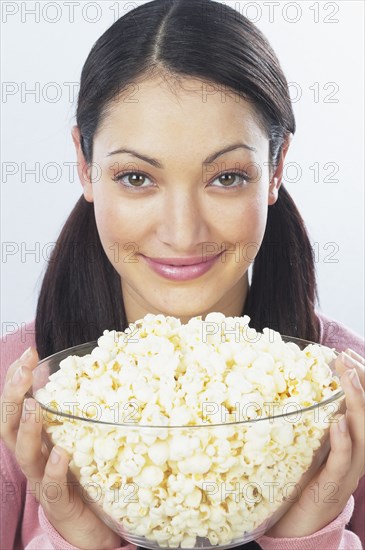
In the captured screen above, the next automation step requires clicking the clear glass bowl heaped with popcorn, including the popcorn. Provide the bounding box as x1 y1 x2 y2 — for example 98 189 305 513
32 312 344 549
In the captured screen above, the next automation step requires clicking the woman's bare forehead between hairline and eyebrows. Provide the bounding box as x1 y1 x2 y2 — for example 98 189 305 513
95 77 264 146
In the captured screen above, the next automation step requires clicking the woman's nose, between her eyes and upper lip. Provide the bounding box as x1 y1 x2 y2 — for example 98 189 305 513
157 189 209 252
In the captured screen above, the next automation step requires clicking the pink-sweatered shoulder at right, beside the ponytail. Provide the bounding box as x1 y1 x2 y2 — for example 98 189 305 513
316 311 365 356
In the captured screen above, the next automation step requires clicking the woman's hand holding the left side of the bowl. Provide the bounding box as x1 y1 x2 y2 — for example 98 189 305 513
1 348 121 550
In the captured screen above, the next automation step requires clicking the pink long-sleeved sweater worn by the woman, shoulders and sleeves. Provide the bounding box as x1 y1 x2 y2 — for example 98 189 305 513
0 314 365 550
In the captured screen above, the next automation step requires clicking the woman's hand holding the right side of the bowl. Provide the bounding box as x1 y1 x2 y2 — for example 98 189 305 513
266 349 365 538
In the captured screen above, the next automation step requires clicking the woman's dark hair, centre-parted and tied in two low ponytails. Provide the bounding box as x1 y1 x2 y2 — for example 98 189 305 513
36 0 318 357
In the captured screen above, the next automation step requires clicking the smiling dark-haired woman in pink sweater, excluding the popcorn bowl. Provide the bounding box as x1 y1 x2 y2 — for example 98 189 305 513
2 0 364 550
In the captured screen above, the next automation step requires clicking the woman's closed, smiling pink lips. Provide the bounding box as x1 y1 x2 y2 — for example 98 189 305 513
142 252 222 281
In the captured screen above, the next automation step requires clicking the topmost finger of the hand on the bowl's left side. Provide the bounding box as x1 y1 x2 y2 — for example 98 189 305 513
1 348 38 451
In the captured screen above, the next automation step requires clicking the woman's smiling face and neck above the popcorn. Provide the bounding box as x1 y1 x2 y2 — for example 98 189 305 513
74 73 280 322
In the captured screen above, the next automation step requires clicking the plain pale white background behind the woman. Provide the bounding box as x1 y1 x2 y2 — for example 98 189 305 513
1 0 364 334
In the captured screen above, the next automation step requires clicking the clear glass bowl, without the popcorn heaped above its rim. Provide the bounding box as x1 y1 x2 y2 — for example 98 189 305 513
29 336 344 549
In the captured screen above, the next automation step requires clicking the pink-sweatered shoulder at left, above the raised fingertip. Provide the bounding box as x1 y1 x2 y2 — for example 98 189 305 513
0 320 35 394
